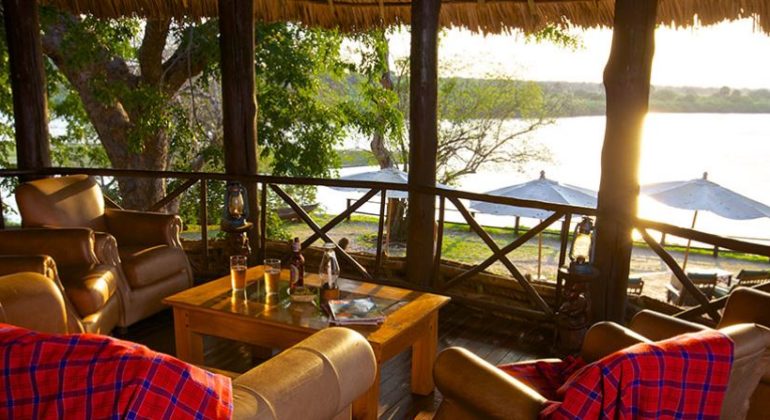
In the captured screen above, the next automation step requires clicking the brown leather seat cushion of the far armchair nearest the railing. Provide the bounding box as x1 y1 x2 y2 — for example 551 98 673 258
118 245 187 289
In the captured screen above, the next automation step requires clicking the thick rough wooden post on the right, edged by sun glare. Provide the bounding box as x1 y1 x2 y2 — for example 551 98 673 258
591 0 658 322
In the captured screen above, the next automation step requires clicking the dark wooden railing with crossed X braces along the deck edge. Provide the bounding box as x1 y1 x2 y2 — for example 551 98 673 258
0 168 770 320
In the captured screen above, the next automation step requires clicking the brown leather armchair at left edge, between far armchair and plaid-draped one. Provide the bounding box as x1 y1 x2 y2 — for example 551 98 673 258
0 240 120 334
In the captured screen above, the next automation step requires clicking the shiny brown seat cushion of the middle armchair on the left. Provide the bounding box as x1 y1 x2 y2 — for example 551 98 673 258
59 264 118 316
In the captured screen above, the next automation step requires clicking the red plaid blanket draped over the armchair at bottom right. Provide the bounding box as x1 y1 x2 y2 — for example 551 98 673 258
505 331 733 419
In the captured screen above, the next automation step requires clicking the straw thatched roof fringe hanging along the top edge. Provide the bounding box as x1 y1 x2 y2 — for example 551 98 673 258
42 0 770 33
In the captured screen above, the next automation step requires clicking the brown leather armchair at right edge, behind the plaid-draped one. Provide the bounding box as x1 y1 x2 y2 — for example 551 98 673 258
629 287 770 419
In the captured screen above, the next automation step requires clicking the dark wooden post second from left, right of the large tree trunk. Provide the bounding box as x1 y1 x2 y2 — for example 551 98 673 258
218 0 264 256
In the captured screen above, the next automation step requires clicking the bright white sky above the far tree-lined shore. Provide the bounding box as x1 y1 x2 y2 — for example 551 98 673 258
390 19 770 89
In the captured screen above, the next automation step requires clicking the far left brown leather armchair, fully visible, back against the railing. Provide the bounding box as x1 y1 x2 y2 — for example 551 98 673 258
16 175 193 327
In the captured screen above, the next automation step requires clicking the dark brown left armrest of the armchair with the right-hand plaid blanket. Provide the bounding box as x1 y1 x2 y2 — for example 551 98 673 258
433 347 546 419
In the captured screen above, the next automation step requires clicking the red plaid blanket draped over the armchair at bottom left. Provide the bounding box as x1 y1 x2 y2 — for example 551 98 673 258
0 324 232 419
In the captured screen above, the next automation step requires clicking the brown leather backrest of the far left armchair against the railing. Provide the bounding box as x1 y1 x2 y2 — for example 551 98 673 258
16 175 106 231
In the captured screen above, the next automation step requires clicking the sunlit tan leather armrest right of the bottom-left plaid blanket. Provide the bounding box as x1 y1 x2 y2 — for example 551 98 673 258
233 328 377 419
